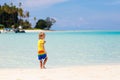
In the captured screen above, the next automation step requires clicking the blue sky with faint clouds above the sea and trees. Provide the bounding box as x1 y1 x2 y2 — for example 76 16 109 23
0 0 120 30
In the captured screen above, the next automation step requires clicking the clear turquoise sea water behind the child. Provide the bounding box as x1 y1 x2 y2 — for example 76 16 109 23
0 31 120 68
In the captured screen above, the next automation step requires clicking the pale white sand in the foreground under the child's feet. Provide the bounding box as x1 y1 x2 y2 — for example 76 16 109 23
0 65 120 80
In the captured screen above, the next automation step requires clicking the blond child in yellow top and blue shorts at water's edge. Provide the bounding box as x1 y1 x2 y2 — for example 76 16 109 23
38 32 48 69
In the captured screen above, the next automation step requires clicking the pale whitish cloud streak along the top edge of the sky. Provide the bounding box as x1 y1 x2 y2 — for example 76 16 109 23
23 0 68 8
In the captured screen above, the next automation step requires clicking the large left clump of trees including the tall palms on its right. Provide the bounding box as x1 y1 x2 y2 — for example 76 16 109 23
0 3 31 28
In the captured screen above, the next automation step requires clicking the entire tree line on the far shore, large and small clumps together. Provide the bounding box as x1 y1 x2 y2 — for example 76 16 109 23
0 2 56 30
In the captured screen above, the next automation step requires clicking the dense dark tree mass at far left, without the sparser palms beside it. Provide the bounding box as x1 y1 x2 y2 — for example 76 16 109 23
0 4 18 27
